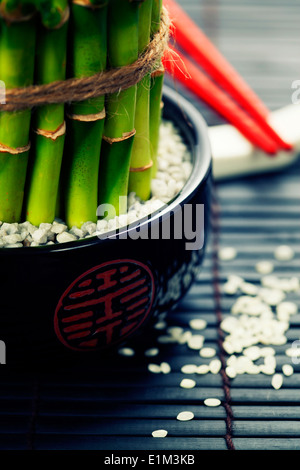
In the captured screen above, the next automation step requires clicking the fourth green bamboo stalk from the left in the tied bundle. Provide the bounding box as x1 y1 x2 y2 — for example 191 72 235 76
99 0 139 218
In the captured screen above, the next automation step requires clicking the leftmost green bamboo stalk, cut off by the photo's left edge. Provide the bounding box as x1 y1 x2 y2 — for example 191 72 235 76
0 0 36 223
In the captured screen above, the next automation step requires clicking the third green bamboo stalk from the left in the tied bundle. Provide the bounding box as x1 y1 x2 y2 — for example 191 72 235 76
62 0 107 227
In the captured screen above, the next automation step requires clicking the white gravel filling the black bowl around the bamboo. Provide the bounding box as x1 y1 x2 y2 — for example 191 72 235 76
0 121 192 248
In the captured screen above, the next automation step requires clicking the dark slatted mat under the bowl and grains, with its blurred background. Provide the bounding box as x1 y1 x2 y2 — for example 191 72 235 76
0 0 300 451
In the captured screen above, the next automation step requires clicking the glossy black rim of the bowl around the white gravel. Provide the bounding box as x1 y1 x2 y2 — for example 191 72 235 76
0 85 212 257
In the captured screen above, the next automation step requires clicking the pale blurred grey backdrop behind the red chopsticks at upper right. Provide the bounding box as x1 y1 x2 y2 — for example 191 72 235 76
166 0 300 125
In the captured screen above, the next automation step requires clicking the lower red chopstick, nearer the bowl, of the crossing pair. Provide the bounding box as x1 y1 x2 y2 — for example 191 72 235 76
163 47 278 154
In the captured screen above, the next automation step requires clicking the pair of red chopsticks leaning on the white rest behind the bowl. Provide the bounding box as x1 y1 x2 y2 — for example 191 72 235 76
163 0 292 155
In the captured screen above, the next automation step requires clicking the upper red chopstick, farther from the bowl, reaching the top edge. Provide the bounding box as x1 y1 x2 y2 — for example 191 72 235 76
164 0 292 150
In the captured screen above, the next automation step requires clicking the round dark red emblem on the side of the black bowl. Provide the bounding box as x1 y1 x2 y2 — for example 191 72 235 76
54 259 155 351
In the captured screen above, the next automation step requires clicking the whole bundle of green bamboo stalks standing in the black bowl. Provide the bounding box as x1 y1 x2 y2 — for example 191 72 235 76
0 0 164 227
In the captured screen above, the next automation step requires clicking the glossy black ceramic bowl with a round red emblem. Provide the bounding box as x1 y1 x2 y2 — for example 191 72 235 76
0 88 211 365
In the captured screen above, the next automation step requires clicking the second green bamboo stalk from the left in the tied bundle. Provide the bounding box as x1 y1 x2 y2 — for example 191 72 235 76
25 0 69 225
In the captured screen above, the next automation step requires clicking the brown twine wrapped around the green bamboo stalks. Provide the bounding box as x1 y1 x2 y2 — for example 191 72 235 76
1 8 170 112
